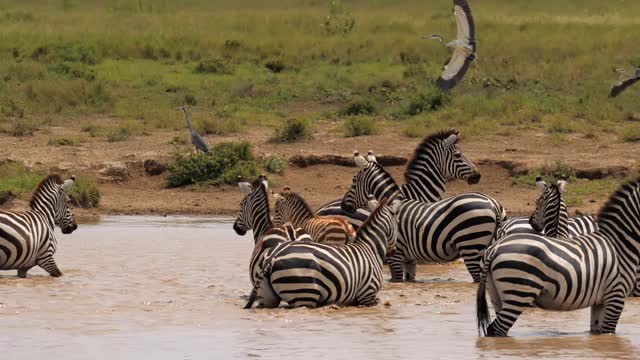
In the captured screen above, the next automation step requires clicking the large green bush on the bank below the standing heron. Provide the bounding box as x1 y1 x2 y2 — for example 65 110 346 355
166 142 259 188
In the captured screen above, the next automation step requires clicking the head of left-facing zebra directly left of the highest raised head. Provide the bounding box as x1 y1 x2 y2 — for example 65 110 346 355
340 162 400 214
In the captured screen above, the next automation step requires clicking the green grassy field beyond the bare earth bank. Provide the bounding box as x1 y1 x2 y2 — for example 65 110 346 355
0 0 640 142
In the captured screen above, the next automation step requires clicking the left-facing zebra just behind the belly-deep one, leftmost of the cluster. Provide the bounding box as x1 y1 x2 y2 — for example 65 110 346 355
233 179 311 306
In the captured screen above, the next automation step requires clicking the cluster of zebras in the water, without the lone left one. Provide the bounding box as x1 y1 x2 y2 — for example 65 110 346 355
233 130 640 336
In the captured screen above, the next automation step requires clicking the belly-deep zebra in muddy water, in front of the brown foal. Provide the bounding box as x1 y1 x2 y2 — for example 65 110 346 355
245 199 398 308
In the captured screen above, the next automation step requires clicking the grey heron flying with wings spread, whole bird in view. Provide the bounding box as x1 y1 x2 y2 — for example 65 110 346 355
425 0 476 91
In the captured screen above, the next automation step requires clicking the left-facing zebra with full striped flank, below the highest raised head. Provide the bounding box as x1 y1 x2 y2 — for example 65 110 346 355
342 163 507 282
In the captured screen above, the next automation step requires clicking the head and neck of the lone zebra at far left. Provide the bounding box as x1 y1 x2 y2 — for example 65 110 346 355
30 175 78 234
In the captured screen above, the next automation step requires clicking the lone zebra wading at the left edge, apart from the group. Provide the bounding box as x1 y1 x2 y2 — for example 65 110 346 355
0 174 78 278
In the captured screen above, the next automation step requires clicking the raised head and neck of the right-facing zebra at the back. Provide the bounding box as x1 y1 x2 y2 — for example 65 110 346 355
405 129 480 192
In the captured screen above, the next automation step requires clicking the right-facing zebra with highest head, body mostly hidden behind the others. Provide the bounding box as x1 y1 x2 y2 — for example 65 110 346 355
316 129 480 229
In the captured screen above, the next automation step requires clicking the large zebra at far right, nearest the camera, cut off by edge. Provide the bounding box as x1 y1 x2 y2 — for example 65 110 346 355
476 178 640 336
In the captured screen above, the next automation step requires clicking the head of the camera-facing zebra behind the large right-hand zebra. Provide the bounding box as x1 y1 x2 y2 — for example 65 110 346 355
529 176 567 236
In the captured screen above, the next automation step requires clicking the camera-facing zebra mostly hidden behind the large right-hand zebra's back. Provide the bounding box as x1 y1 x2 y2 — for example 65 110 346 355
496 176 598 239
